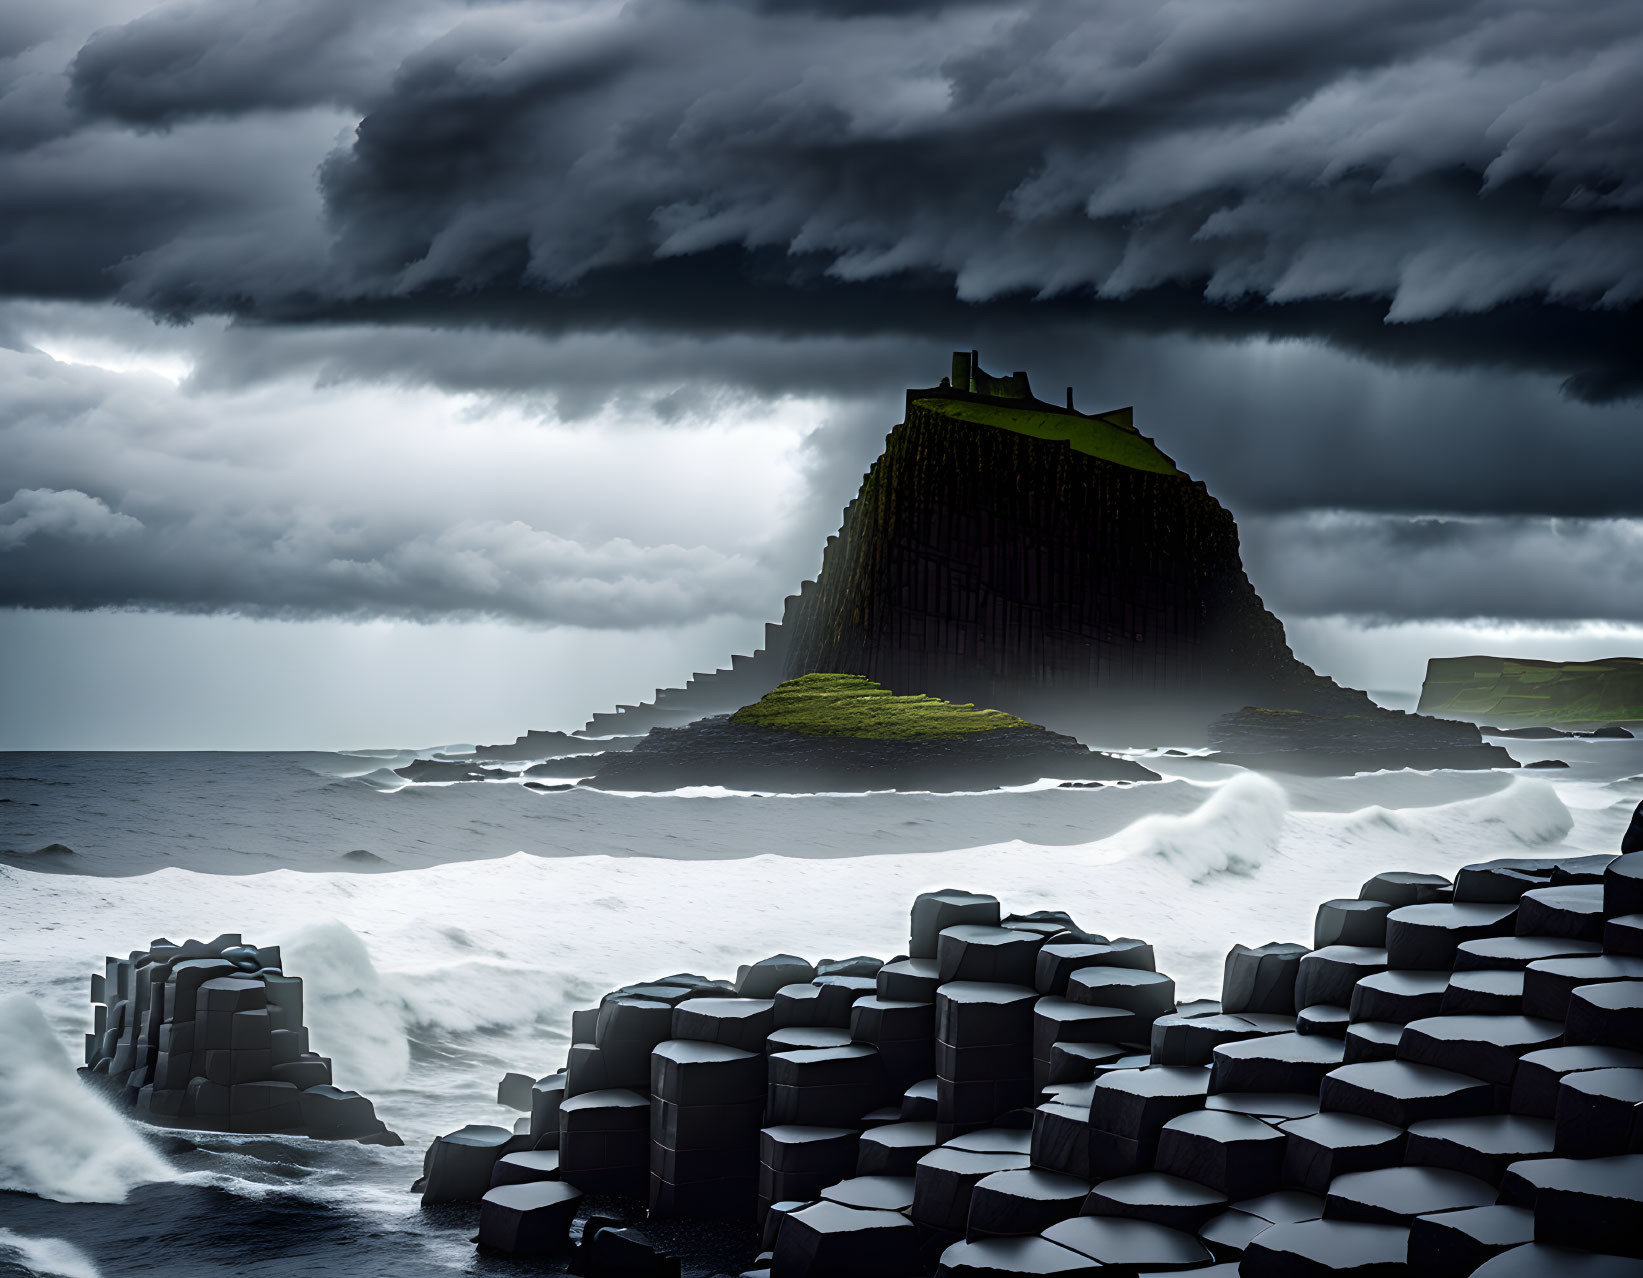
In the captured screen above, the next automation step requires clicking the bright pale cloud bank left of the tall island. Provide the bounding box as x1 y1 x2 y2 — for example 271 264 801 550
0 343 785 629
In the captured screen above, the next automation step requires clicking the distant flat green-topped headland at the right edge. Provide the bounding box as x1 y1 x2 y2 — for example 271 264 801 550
1418 657 1643 728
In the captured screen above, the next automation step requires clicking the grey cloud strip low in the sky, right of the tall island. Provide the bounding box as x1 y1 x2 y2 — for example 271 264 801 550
1242 511 1643 623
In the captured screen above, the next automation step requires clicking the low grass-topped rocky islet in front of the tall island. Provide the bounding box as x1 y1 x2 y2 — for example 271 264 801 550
585 672 1157 793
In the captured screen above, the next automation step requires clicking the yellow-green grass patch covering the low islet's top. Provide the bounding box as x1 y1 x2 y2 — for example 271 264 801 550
731 675 1033 741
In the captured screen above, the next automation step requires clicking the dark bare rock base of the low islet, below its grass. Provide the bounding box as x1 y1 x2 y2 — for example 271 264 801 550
583 716 1158 792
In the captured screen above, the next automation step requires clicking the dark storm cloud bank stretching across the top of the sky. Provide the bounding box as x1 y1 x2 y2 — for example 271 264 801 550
0 0 1643 401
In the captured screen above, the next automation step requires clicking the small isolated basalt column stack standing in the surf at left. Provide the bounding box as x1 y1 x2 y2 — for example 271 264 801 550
85 933 401 1145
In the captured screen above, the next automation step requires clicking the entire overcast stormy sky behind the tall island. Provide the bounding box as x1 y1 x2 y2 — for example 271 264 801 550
0 0 1643 749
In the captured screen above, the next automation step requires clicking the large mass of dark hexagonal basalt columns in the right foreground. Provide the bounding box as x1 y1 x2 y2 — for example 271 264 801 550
419 801 1643 1278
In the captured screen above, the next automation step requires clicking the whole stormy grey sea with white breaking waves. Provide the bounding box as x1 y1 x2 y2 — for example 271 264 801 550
0 739 1643 1278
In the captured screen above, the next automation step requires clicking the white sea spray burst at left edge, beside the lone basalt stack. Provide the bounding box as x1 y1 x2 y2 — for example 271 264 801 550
0 994 171 1195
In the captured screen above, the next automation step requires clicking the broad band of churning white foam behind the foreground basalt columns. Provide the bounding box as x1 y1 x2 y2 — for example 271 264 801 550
0 774 1623 1152
